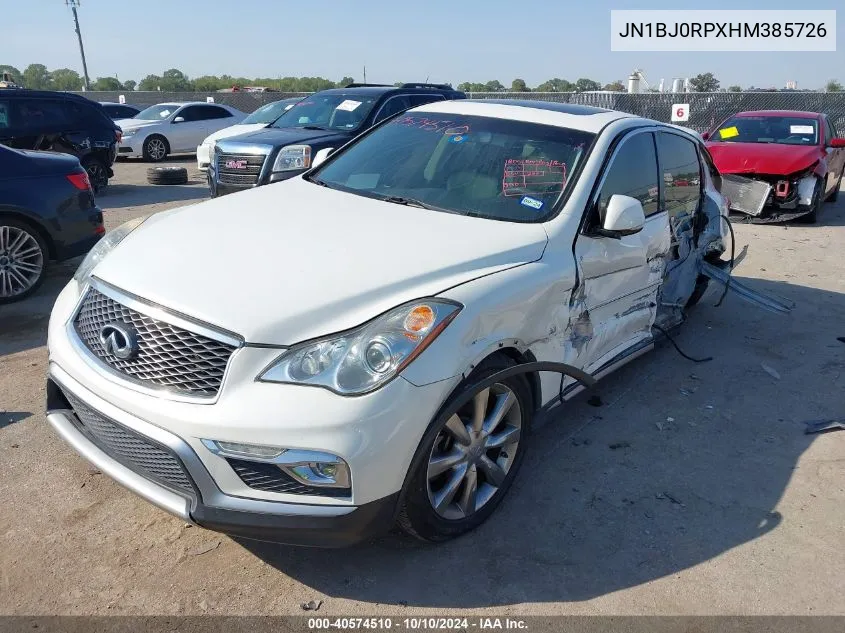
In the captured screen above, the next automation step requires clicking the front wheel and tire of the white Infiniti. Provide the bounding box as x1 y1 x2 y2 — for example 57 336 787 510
397 356 534 542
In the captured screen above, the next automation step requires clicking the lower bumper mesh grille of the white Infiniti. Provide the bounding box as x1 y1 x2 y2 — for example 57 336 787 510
63 391 195 495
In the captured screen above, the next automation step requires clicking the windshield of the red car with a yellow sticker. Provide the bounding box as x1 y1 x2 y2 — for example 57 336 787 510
708 116 819 145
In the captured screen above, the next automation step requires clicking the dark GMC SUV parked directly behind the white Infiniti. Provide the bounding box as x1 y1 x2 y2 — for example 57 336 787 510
208 83 466 197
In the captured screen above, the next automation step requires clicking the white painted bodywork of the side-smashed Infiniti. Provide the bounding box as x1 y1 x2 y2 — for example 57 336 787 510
48 101 726 544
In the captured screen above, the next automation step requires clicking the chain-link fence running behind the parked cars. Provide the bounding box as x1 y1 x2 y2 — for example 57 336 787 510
78 92 845 135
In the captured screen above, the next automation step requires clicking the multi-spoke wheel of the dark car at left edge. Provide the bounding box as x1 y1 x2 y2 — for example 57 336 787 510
0 217 48 304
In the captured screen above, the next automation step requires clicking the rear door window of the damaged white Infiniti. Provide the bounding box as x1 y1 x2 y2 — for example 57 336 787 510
657 132 701 218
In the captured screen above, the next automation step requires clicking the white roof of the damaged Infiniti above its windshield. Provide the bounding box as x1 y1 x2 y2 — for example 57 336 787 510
409 99 638 133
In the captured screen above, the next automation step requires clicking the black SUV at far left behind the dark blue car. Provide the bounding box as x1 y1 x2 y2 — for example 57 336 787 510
0 89 120 191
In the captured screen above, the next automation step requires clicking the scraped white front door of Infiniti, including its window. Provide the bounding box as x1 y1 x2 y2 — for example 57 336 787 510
565 130 671 373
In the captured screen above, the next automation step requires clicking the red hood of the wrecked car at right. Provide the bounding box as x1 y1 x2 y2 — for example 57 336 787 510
707 143 819 176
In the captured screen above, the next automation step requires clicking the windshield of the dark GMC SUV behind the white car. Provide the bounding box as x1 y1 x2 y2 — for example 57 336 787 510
273 93 376 130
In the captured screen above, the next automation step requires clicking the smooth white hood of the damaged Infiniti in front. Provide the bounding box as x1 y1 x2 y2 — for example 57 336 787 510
94 178 547 345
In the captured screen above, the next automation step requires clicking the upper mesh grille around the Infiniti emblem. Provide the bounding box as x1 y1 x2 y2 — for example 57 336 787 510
73 288 236 397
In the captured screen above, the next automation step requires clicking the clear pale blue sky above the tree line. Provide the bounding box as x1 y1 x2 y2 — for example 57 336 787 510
0 0 845 88
